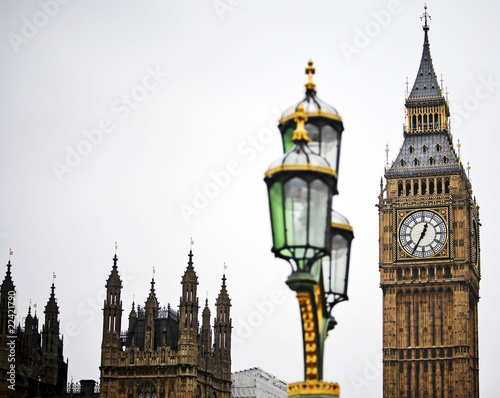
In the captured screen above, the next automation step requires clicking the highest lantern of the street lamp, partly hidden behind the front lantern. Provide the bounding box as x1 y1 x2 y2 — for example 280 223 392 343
278 61 344 180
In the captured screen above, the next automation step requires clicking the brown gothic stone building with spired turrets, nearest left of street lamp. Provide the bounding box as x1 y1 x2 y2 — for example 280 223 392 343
100 251 231 398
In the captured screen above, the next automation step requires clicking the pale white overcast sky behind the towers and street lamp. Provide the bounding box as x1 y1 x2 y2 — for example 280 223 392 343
0 0 500 397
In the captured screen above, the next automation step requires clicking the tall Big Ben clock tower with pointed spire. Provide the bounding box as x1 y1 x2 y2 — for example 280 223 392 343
378 7 481 398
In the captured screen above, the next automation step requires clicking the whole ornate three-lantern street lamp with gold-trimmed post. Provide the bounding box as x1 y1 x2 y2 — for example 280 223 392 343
264 61 354 398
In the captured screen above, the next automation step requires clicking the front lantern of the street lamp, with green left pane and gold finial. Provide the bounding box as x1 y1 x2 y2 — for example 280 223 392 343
264 105 336 282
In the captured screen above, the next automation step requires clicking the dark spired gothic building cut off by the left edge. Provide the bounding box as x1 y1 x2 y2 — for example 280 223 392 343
0 260 68 398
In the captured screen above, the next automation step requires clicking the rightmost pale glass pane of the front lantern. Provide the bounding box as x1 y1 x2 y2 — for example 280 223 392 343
309 180 331 249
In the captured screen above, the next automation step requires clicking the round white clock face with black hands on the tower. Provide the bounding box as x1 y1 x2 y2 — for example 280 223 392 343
399 210 447 257
